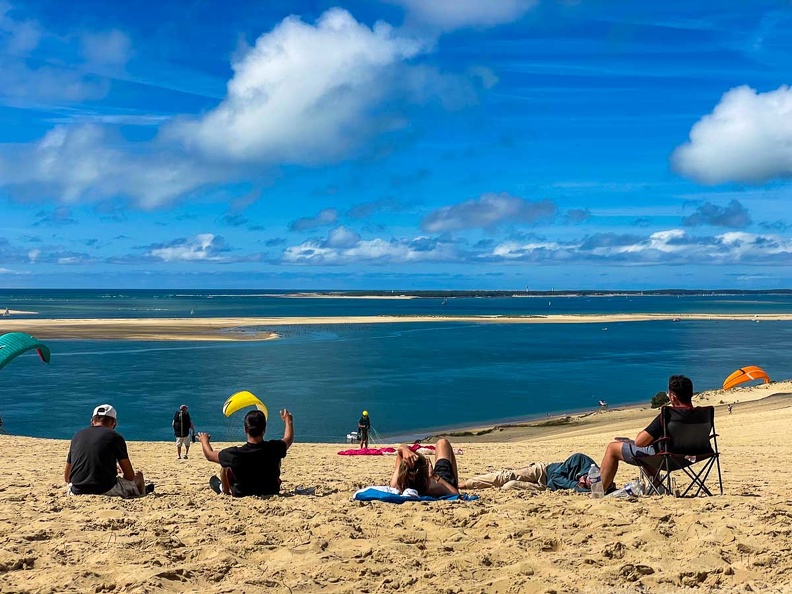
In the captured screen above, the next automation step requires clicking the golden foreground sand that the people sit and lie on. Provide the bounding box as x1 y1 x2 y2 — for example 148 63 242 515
0 383 792 594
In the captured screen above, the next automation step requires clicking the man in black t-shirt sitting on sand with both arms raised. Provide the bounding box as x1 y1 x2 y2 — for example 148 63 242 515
198 409 294 497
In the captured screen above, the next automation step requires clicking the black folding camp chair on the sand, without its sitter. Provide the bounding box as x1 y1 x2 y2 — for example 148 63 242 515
635 406 723 497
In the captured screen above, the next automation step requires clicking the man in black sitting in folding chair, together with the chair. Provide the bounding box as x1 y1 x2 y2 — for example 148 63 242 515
601 375 723 497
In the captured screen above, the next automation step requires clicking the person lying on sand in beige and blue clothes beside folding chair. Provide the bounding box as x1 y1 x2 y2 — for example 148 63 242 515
459 454 595 492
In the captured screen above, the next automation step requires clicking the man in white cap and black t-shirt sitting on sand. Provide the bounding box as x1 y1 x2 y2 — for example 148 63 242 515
63 404 148 498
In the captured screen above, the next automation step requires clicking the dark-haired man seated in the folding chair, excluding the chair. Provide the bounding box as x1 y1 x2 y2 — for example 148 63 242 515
600 375 694 493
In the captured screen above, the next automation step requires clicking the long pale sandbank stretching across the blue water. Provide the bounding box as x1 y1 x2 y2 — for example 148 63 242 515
0 313 792 340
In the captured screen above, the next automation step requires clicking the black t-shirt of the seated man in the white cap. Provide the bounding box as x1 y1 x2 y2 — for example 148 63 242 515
66 426 129 495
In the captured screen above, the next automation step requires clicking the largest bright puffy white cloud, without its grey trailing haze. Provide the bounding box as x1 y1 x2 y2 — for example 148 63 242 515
166 8 425 164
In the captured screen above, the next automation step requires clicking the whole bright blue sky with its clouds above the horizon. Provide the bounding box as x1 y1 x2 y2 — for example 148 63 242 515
0 0 792 290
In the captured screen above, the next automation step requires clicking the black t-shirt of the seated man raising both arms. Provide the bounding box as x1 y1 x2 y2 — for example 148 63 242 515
219 439 287 497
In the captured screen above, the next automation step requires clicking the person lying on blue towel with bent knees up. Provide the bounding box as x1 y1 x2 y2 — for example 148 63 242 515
390 438 459 497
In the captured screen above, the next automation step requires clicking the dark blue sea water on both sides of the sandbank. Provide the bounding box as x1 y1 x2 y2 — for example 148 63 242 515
0 290 792 443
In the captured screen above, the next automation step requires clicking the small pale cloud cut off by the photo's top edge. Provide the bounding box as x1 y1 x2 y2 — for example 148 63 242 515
389 0 538 31
